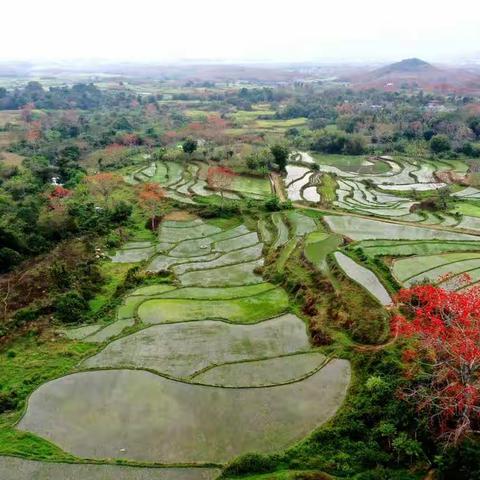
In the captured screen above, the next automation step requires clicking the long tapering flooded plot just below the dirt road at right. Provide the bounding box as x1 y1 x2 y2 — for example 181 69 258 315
324 215 480 241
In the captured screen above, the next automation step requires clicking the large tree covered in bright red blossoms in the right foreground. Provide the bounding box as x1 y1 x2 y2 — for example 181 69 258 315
392 285 480 443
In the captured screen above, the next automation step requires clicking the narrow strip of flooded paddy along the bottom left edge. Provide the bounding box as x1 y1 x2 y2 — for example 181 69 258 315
0 457 220 480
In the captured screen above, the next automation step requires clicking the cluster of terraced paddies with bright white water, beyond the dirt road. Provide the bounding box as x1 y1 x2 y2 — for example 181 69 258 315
285 152 480 231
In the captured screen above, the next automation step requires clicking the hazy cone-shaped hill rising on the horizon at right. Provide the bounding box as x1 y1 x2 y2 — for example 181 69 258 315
348 58 480 93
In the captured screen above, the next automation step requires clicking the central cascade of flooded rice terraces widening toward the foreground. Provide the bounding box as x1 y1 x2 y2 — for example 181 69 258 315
20 216 350 466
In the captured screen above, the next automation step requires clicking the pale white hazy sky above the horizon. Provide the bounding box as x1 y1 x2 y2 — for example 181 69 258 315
0 0 480 61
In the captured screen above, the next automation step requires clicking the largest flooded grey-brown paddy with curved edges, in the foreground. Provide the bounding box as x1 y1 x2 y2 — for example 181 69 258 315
18 366 350 463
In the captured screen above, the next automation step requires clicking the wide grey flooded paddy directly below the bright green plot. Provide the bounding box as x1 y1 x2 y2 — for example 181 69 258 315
82 314 308 378
